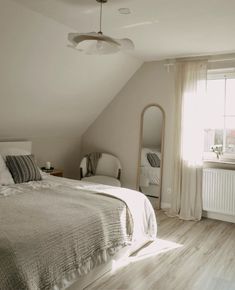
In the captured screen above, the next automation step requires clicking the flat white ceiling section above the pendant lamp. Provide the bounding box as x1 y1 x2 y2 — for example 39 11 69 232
15 0 235 61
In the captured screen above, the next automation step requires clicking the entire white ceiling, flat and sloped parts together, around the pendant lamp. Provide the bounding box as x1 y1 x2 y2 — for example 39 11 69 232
0 0 235 138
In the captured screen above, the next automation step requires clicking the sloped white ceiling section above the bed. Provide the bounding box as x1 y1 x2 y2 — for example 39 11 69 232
0 0 142 139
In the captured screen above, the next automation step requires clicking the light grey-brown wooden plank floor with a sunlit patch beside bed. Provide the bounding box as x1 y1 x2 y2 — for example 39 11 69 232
86 211 235 290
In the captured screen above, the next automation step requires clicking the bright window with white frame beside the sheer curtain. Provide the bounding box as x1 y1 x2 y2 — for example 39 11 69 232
204 69 235 161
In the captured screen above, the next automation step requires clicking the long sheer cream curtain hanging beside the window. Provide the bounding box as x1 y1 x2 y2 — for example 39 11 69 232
170 61 207 220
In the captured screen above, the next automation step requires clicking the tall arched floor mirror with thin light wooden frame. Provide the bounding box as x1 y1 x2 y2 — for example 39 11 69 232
137 104 165 209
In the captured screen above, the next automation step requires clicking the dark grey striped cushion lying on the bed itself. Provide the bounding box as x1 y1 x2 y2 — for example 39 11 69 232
6 155 42 183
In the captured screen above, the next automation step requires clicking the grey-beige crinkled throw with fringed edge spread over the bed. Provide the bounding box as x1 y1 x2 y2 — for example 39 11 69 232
0 180 132 290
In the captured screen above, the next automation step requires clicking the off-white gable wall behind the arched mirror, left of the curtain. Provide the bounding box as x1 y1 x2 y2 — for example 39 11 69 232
82 62 174 203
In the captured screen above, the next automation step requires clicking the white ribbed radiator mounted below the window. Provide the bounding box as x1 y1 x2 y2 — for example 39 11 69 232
202 168 235 215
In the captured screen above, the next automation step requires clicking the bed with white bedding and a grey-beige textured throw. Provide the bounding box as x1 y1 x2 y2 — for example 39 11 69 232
0 142 157 290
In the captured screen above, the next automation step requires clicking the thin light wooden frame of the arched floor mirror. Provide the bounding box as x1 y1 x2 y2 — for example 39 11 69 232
136 103 166 209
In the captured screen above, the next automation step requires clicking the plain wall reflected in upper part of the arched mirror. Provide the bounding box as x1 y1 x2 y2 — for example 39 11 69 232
143 106 163 148
